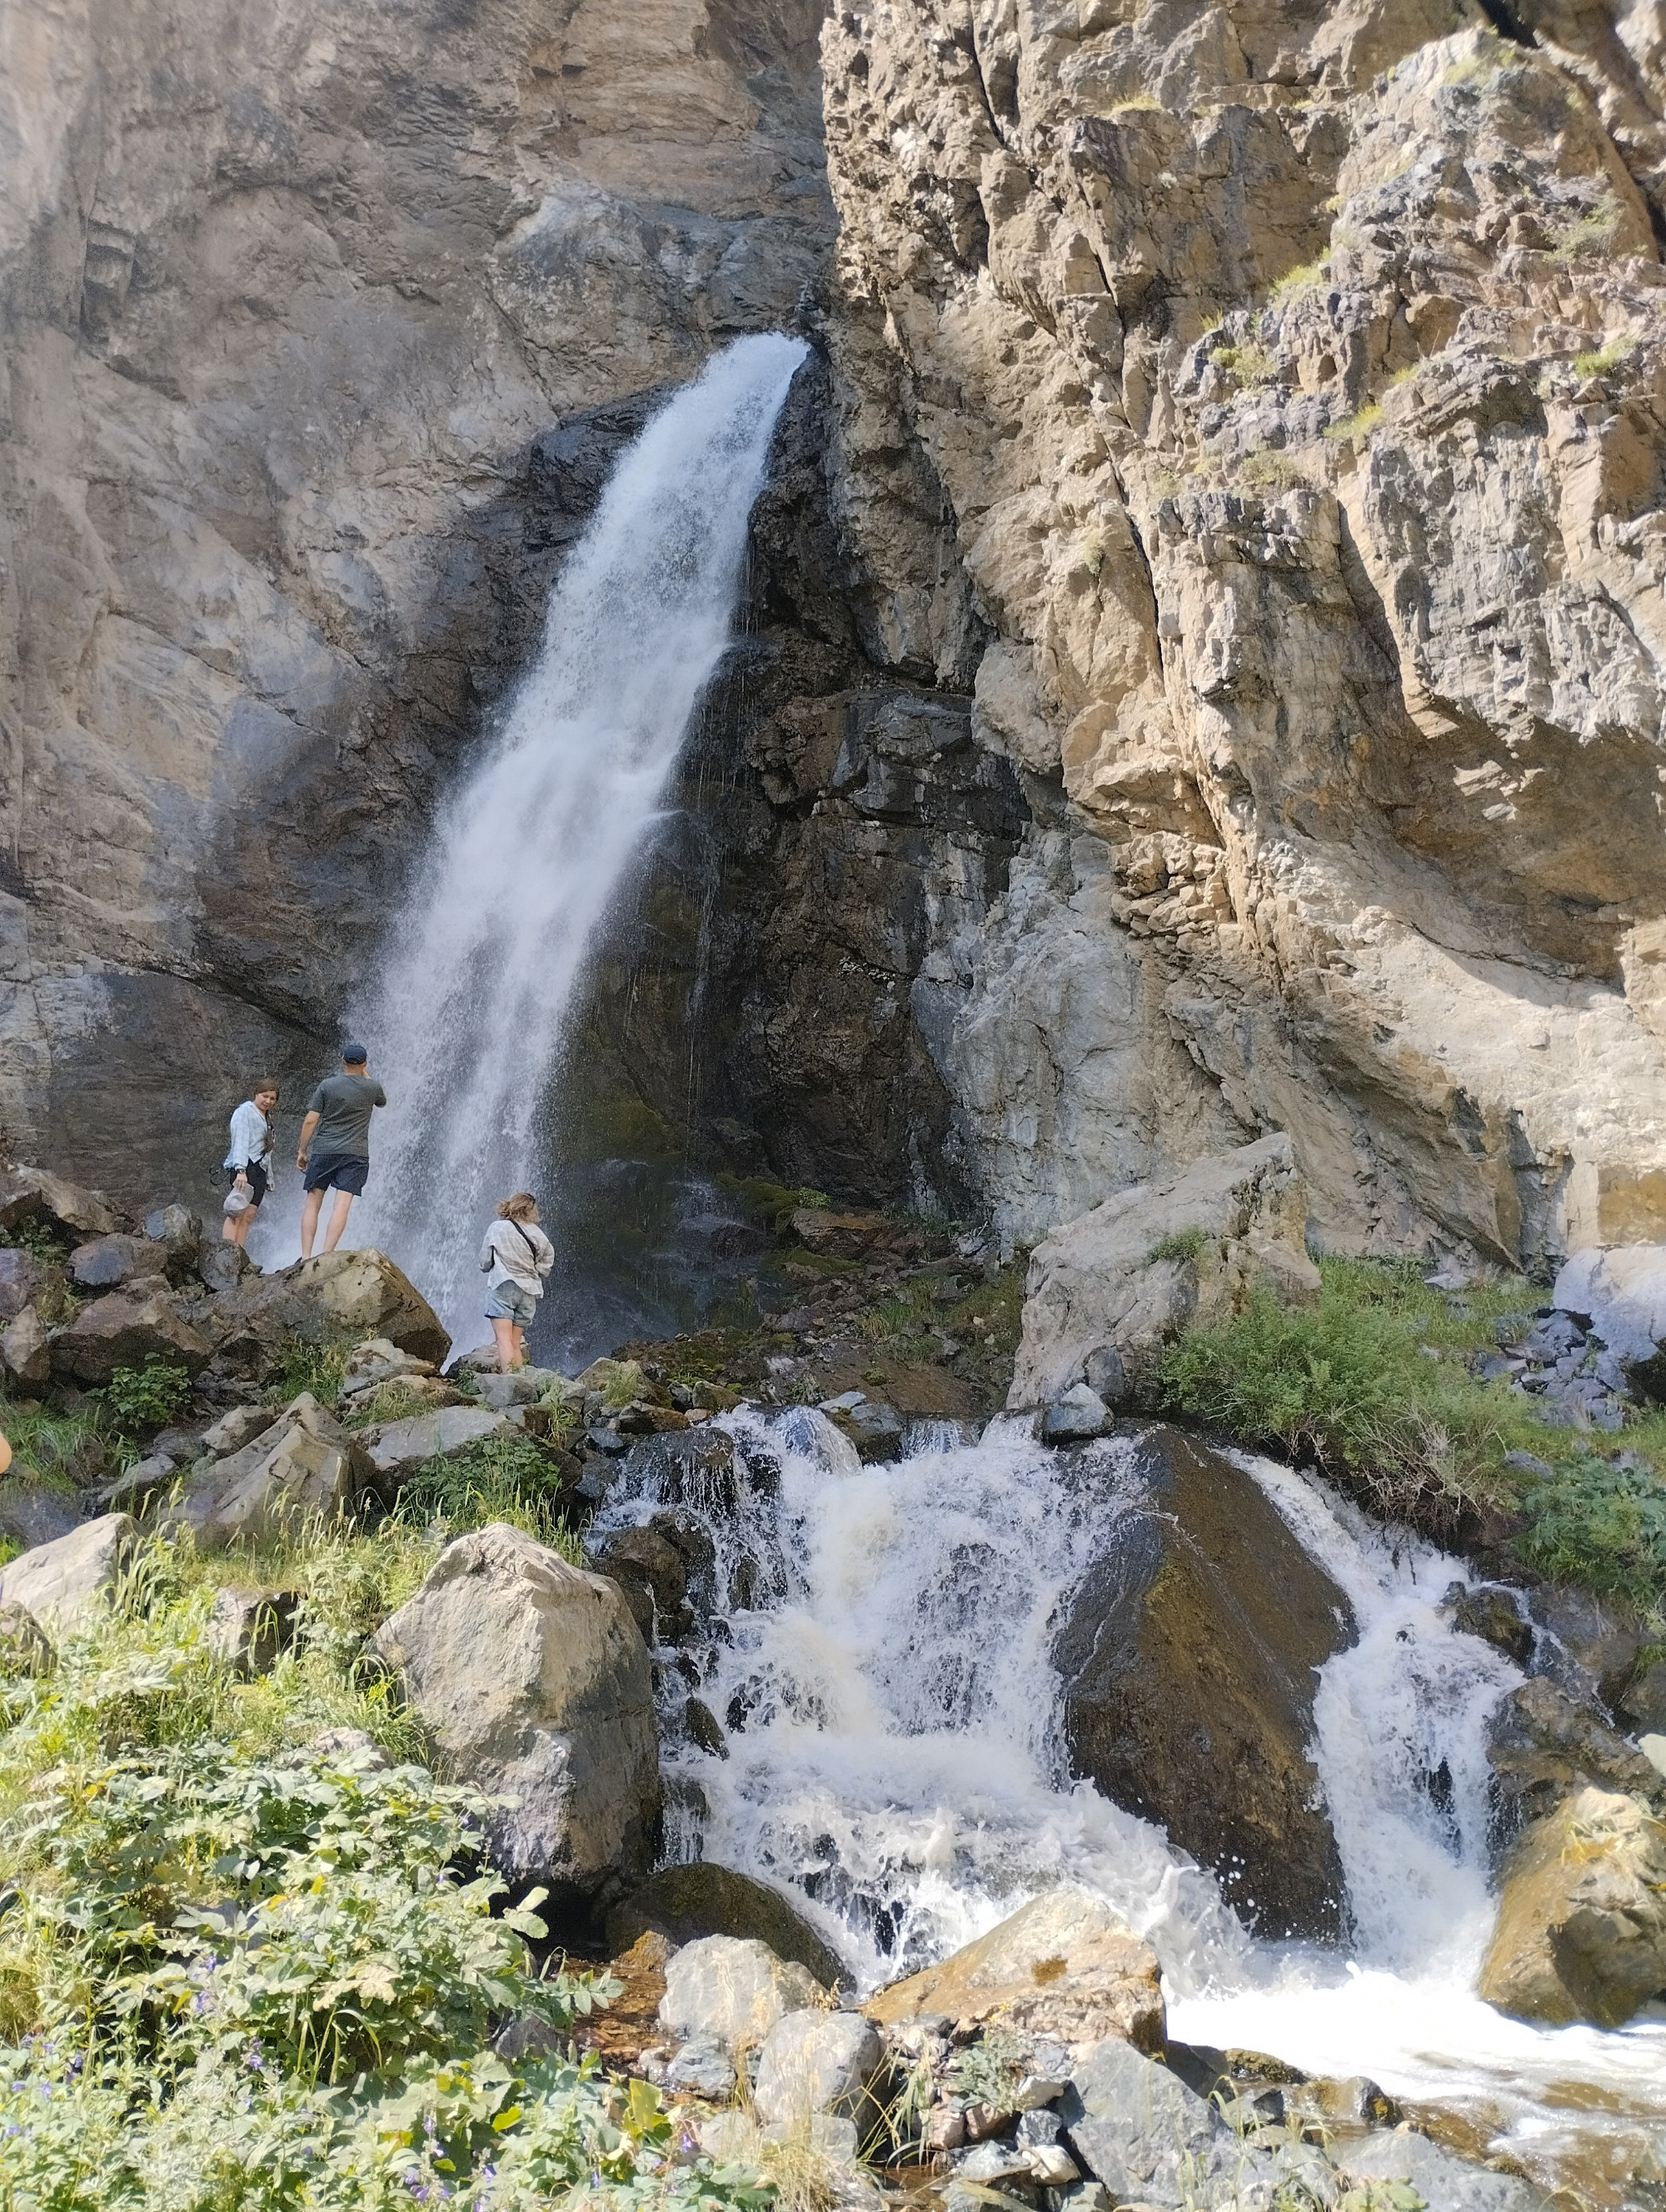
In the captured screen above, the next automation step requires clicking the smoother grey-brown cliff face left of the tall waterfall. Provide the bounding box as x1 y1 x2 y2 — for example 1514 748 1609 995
0 0 832 1197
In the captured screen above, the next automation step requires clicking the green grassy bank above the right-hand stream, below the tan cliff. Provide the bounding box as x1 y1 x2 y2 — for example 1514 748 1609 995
1160 1258 1666 1617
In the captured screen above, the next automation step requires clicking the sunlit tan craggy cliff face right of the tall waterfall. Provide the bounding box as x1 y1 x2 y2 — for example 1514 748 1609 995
823 0 1666 1261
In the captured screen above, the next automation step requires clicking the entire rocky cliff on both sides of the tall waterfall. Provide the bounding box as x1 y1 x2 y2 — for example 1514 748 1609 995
0 0 1666 1265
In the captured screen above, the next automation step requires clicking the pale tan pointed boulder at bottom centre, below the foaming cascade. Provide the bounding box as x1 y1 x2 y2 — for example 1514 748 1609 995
863 1885 1164 2050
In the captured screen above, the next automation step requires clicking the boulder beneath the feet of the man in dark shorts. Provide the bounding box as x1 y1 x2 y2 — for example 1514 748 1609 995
215 1245 451 1373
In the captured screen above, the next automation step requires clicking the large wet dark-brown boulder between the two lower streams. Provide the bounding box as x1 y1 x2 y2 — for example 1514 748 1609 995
1053 1422 1354 1938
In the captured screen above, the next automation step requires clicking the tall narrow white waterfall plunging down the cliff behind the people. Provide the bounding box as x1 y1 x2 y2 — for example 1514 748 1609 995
255 336 807 1345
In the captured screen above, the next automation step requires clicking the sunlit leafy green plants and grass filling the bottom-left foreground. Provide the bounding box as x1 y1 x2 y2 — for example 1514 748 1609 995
0 1528 770 2212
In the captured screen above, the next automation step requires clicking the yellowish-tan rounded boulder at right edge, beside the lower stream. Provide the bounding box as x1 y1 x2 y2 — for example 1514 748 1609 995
1480 1790 1666 2029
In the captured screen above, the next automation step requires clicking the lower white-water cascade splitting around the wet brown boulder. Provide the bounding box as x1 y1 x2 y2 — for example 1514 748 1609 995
597 1409 1666 2205
